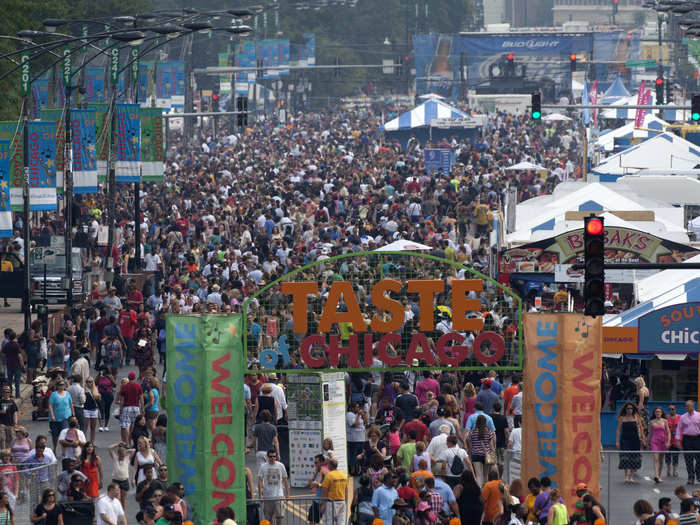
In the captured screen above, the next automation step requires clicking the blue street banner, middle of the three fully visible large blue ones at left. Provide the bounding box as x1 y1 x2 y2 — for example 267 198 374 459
70 109 97 193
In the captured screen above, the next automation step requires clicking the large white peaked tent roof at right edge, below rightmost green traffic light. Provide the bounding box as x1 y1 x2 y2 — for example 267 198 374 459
593 133 700 177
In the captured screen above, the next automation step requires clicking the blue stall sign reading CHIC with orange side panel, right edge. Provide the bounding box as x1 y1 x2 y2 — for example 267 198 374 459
603 302 700 354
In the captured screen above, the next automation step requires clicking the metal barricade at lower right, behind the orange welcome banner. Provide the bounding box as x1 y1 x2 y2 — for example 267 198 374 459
503 450 700 525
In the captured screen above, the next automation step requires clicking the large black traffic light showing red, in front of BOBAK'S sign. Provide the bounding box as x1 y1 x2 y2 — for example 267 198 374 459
583 217 605 317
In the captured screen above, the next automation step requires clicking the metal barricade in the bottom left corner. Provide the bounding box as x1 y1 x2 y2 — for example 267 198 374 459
0 462 61 525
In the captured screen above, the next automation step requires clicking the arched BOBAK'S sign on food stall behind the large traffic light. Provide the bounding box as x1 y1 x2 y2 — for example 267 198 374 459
499 226 698 273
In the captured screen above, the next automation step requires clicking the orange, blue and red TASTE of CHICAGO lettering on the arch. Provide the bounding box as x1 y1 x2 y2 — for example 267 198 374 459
276 279 506 368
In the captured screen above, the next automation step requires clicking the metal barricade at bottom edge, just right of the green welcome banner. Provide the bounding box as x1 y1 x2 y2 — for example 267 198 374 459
246 497 340 525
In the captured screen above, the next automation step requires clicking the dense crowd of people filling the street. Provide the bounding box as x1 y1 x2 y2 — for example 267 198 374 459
0 101 680 525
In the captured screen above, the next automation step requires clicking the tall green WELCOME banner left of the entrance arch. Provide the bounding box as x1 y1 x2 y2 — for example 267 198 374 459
166 315 246 525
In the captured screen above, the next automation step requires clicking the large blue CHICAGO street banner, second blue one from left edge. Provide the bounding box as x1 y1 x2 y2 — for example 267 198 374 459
27 121 57 211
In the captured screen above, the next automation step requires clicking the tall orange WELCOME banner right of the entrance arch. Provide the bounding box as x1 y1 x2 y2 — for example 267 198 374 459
521 313 602 510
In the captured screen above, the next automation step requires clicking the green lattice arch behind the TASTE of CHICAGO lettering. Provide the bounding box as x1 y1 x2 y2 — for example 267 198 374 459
242 251 523 373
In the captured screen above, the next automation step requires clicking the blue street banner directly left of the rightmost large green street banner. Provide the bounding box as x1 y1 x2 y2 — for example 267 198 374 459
116 104 141 183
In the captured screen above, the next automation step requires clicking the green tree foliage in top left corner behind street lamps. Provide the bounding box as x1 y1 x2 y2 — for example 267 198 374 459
0 0 150 120
